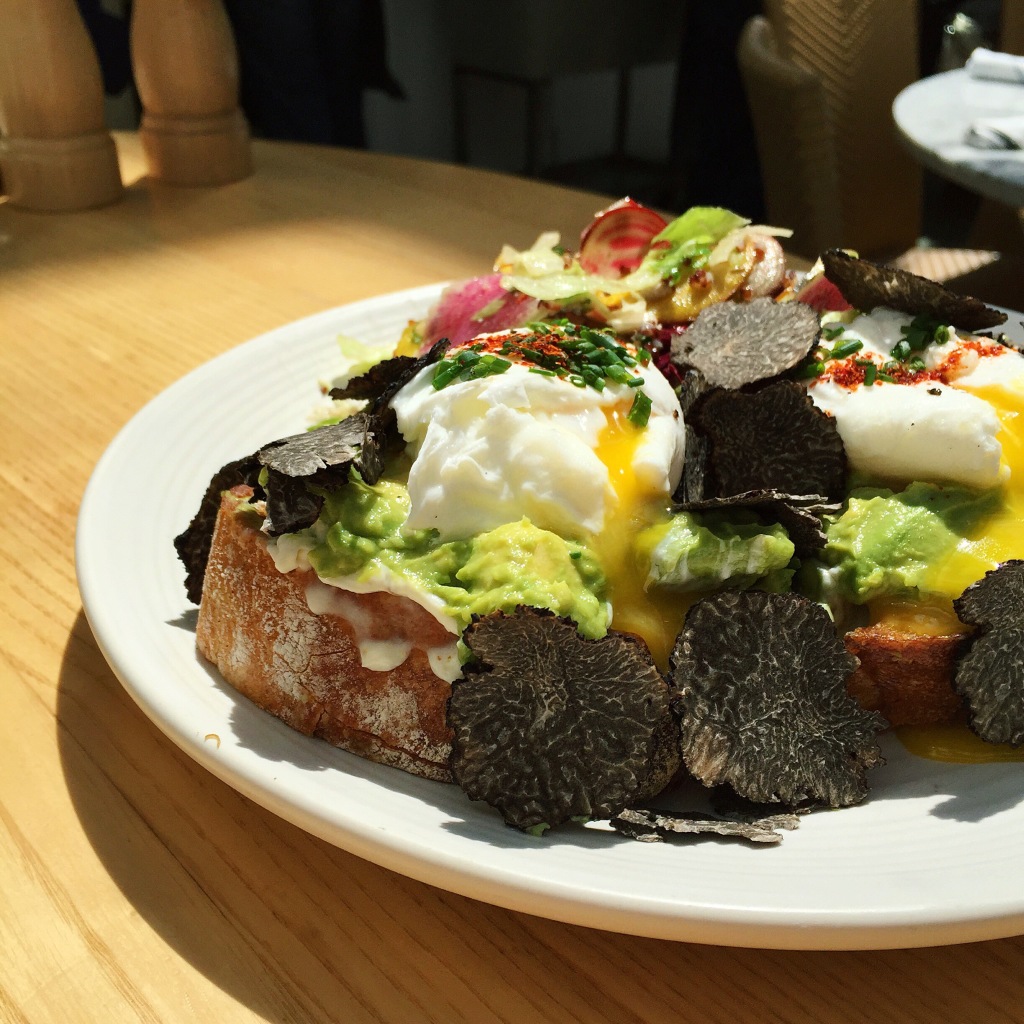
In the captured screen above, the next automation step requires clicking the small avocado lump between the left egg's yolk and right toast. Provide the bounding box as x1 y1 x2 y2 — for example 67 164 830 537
638 510 794 592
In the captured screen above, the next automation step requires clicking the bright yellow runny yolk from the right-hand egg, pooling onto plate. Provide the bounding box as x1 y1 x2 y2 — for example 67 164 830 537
884 379 1024 764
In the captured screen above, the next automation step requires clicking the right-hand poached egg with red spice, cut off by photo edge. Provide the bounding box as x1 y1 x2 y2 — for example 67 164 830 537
808 308 1024 606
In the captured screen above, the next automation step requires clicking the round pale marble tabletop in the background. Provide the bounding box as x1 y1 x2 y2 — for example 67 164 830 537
893 70 1024 207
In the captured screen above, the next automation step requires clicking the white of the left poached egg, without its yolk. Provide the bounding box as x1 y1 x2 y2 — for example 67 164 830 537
391 335 685 540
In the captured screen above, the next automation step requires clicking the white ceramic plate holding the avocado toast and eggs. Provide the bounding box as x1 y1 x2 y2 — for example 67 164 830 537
77 287 1024 949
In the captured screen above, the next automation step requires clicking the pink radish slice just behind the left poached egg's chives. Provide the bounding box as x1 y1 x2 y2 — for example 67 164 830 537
421 273 541 351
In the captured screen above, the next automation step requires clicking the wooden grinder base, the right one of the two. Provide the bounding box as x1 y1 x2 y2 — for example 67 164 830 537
131 0 252 185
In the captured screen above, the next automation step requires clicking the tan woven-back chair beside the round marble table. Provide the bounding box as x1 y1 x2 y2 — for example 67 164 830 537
738 0 922 257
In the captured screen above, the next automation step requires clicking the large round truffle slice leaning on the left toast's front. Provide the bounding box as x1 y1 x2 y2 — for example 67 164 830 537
447 607 678 830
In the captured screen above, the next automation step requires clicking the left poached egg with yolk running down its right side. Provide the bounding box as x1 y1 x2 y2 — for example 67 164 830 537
391 329 685 664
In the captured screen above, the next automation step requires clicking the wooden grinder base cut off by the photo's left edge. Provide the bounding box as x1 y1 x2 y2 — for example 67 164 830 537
0 0 122 212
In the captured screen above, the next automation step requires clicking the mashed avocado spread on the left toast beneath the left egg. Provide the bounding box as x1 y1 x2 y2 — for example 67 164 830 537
309 474 608 637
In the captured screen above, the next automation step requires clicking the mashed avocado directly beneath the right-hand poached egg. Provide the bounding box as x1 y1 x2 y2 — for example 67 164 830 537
822 481 999 604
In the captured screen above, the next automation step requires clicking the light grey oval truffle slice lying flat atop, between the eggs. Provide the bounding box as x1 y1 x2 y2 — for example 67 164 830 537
672 298 821 388
